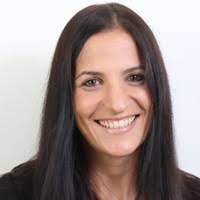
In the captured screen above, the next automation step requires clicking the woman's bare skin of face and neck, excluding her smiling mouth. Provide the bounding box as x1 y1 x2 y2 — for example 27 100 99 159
75 27 152 200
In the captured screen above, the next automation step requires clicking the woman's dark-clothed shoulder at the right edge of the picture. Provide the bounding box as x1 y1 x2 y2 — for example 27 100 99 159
181 171 200 200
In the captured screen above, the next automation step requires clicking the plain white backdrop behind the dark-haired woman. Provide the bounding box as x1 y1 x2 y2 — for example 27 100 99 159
0 0 200 176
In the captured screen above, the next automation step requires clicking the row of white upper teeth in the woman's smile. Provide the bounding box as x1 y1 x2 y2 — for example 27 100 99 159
98 115 136 128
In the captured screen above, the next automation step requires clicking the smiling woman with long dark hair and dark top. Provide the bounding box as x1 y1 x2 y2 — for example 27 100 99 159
0 3 200 200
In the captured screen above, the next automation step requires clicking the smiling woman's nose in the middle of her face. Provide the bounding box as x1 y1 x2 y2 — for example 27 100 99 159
104 84 128 114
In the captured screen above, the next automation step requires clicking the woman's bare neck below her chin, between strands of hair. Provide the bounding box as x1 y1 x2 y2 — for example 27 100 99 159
86 147 138 200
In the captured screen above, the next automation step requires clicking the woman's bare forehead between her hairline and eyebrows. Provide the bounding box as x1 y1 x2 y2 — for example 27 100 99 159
76 28 140 72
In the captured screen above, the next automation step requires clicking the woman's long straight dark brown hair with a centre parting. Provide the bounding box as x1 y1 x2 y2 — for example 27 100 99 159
5 3 198 200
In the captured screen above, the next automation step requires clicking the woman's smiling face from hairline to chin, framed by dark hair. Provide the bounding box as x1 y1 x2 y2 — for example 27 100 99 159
75 29 152 156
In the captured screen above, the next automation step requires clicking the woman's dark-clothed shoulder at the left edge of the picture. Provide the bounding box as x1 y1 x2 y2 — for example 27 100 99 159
0 163 32 200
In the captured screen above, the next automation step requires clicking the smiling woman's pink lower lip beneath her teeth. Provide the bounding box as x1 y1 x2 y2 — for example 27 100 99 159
95 115 139 134
